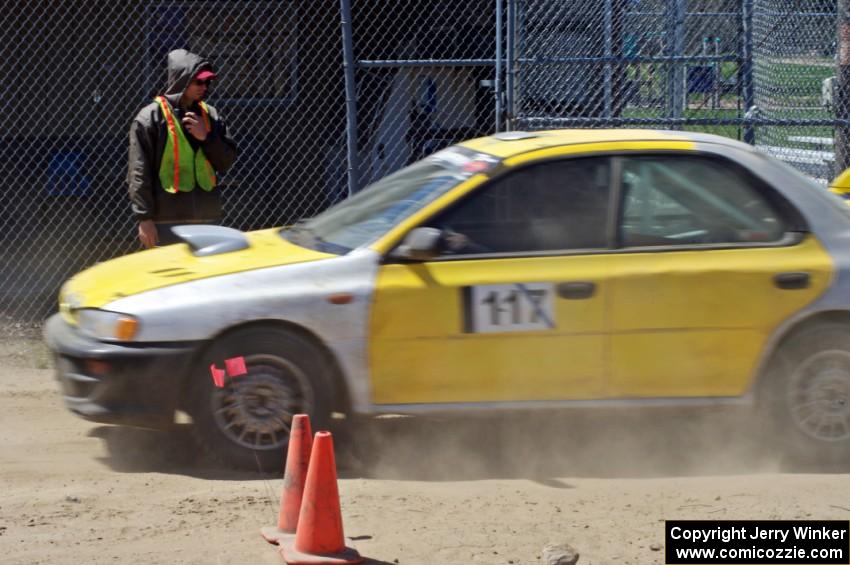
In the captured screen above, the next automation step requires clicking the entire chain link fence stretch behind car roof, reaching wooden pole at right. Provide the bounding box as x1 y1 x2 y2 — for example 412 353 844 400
516 0 847 176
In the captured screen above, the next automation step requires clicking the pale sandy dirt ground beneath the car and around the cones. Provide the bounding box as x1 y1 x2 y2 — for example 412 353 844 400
0 340 850 565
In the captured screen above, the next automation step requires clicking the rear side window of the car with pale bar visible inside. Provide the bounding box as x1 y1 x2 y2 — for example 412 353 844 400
619 155 786 247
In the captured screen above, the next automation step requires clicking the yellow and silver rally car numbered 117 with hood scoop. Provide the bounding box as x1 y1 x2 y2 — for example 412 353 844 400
45 130 850 467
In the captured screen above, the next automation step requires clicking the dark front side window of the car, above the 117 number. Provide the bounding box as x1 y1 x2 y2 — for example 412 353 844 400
427 157 610 255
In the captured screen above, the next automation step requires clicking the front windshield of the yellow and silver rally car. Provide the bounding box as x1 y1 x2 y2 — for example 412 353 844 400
282 147 498 254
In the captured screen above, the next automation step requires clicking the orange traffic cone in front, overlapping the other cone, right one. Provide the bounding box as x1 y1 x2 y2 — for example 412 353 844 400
280 432 363 565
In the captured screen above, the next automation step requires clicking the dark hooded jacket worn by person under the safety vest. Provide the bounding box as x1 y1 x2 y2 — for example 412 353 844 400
127 49 236 222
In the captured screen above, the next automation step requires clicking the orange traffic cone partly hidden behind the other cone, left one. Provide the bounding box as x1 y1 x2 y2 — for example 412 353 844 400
260 414 313 544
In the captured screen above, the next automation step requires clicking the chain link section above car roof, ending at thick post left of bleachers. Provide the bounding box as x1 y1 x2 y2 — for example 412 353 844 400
517 0 742 133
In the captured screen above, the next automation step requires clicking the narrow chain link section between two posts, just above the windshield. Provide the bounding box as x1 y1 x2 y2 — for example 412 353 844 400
343 0 497 190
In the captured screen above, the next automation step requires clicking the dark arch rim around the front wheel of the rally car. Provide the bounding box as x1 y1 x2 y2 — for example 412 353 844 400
178 318 351 414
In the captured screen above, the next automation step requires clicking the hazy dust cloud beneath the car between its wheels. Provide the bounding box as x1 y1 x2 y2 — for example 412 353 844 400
336 408 788 480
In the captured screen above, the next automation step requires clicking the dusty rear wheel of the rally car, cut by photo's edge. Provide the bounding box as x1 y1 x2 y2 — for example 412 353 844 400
760 323 850 465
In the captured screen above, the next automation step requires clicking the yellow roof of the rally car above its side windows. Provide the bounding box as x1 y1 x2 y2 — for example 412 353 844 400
459 129 752 159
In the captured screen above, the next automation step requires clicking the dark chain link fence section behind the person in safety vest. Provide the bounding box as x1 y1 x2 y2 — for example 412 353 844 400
0 0 345 325
